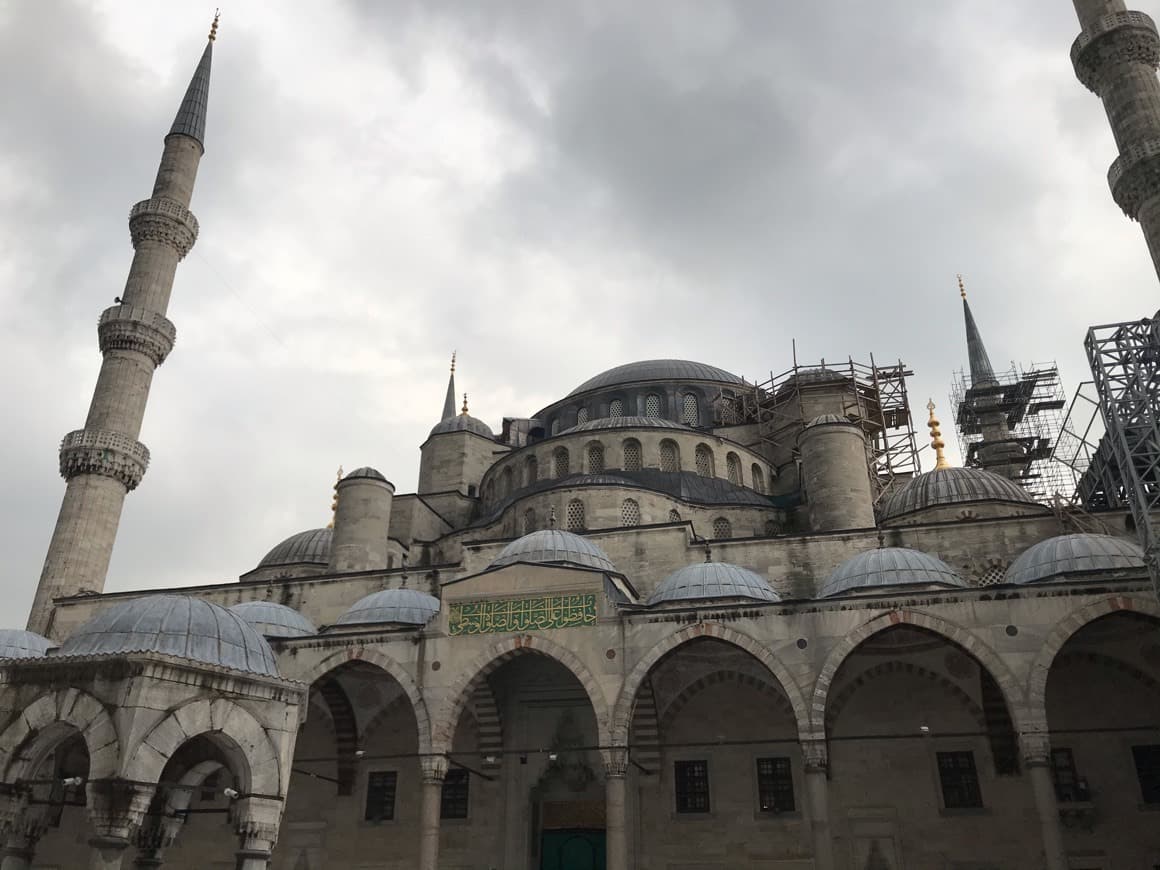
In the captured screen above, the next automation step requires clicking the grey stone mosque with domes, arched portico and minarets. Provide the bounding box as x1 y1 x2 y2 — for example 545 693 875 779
0 0 1160 870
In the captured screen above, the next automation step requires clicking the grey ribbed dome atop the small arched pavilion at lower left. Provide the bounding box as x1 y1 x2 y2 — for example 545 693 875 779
58 595 278 676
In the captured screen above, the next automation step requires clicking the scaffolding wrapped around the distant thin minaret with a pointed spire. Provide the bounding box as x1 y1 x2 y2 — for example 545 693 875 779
950 362 1075 505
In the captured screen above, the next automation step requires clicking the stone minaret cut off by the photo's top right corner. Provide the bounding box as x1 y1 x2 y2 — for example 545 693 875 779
1072 0 1160 279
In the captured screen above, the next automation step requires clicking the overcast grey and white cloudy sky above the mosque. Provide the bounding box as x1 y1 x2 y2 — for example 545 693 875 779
0 0 1160 612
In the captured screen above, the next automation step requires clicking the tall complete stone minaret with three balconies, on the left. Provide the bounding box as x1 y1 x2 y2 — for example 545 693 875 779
28 17 218 633
